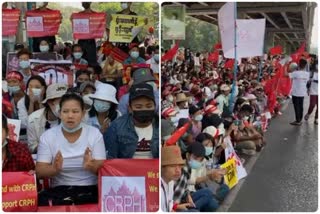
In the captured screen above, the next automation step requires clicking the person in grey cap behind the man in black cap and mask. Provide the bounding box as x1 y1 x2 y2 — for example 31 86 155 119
118 68 159 115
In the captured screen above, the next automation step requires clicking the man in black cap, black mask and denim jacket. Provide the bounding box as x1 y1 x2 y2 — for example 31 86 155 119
104 83 159 159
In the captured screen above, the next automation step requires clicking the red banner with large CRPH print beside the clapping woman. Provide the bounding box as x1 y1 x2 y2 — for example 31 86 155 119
99 159 159 212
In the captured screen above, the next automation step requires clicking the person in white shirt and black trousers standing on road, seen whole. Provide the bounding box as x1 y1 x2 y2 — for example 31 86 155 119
289 59 309 126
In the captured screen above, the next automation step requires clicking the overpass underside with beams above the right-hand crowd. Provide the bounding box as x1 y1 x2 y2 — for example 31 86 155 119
162 2 317 53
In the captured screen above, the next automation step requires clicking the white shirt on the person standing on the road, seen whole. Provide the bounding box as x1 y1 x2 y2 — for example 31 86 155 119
289 71 309 97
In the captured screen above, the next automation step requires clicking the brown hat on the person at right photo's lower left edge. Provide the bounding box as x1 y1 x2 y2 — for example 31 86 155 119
161 146 185 166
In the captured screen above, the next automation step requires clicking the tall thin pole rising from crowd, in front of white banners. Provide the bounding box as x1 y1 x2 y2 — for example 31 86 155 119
229 2 238 112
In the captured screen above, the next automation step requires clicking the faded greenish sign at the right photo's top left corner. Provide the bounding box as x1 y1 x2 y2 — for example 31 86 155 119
162 5 186 40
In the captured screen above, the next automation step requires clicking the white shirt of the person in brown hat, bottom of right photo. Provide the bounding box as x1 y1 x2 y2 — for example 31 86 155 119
161 178 174 212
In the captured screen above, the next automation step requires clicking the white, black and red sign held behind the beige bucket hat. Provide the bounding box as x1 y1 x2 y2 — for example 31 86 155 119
30 59 74 87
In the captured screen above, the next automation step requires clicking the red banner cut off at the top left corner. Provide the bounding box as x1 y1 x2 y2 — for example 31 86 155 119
2 9 20 36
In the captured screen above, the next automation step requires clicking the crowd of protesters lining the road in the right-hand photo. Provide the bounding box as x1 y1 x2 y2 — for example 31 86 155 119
161 48 318 212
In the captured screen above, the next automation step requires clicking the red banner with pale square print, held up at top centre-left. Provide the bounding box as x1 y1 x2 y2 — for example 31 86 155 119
71 13 106 39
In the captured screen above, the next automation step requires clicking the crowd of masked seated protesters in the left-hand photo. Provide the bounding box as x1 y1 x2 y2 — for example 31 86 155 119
2 2 160 206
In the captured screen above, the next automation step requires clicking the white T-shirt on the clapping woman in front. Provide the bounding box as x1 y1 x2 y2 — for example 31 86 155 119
37 124 106 187
